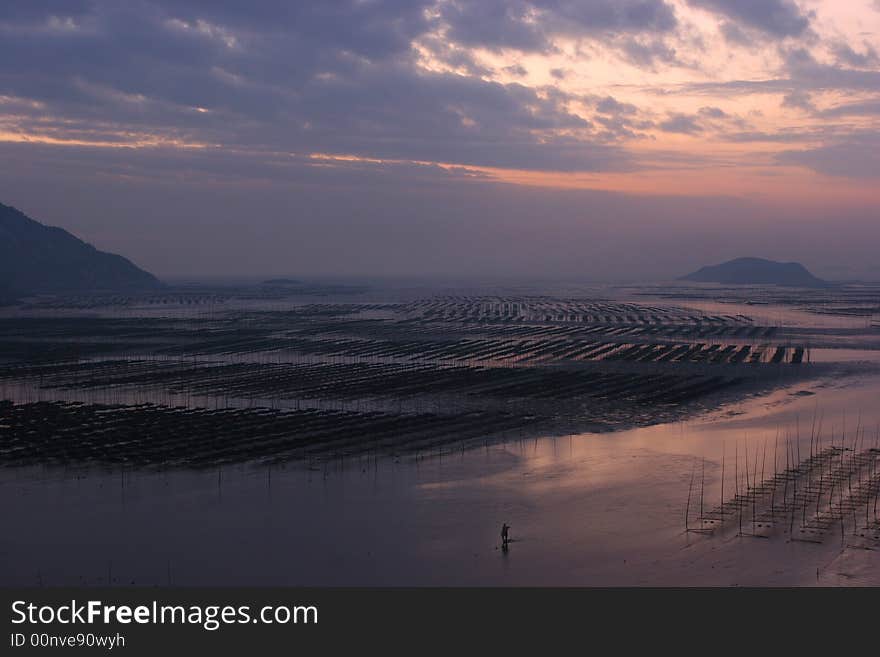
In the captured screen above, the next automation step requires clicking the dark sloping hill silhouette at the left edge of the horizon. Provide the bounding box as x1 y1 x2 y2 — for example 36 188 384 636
0 197 162 294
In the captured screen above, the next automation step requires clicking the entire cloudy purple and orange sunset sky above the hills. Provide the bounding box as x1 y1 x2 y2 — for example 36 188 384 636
0 0 880 280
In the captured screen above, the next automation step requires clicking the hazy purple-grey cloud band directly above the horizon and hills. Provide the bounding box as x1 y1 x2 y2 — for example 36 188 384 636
8 136 880 281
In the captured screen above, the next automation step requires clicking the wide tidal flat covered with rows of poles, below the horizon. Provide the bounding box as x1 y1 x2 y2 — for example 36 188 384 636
0 287 880 586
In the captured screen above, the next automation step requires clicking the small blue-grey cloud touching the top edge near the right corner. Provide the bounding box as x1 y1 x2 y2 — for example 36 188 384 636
688 0 811 41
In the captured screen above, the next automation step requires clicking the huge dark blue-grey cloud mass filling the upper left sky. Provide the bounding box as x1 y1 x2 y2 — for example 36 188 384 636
0 0 648 171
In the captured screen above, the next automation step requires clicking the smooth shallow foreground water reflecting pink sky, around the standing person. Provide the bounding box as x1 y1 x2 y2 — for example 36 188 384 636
0 366 880 585
